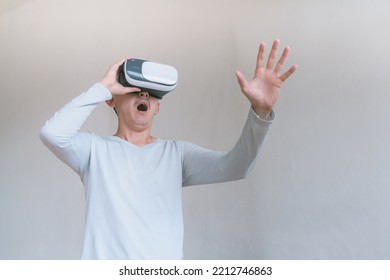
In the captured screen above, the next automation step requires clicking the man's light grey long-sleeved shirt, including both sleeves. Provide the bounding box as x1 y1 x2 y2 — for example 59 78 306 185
40 84 273 259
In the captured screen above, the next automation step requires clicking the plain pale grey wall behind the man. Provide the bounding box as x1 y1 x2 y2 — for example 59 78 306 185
0 0 390 259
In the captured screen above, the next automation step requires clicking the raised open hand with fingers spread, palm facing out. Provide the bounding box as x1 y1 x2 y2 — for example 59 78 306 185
236 40 298 119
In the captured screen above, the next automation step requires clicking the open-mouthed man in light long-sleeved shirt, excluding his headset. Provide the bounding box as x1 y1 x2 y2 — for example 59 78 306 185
40 40 297 259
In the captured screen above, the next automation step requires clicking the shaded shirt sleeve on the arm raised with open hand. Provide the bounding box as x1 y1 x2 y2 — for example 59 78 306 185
182 109 275 186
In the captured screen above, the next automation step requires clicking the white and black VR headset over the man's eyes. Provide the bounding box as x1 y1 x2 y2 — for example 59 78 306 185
118 58 178 99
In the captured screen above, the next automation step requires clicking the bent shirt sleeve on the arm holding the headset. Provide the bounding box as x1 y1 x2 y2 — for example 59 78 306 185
39 83 112 174
